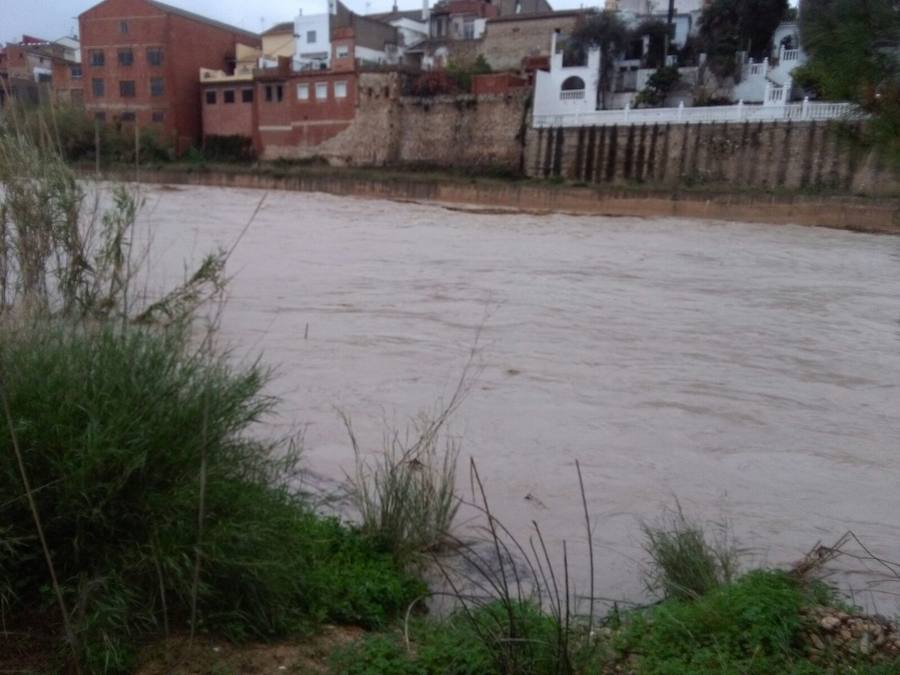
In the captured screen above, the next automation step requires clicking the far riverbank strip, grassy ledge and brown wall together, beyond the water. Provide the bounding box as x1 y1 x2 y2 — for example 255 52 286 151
91 163 900 234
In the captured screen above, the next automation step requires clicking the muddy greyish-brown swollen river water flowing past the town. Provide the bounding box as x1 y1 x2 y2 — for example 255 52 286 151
135 186 900 605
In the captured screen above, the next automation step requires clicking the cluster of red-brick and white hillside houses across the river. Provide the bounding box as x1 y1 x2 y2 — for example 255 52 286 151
0 0 860 158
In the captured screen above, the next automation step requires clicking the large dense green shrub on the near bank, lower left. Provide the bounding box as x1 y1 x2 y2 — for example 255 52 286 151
0 323 421 672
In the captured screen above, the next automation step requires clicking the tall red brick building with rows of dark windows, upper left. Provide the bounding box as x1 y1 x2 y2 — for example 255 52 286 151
79 0 261 152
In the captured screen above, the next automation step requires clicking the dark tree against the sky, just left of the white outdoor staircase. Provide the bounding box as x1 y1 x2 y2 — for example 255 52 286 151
700 0 788 75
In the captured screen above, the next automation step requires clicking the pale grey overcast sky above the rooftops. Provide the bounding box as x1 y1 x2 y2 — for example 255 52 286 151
0 0 584 42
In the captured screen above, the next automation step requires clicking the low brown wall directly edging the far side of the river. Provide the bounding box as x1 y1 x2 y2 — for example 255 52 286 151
111 170 900 234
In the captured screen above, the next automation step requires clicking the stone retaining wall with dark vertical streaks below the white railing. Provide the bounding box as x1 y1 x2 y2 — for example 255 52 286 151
525 122 900 195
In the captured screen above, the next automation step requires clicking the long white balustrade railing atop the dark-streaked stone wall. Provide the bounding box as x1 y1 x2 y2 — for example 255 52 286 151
533 100 863 129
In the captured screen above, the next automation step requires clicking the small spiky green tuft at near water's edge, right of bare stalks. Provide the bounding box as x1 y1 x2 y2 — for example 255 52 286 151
643 506 738 599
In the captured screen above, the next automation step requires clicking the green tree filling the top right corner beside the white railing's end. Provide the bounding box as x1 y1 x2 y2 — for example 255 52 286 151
794 0 900 162
